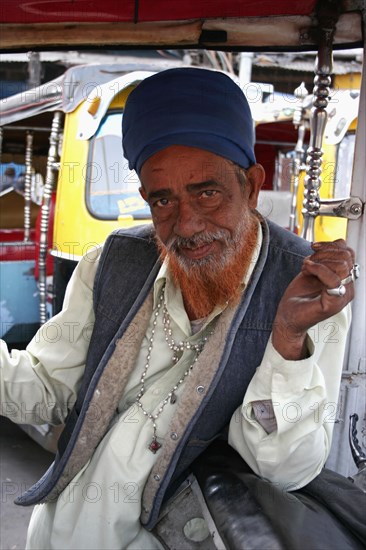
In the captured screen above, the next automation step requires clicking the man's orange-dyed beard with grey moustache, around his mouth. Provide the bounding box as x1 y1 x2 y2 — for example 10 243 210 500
157 211 258 320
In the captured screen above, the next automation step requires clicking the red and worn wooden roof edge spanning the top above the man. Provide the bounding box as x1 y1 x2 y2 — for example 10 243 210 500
0 0 364 51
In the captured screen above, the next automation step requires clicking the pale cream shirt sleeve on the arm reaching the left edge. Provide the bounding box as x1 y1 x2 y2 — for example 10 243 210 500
0 247 101 430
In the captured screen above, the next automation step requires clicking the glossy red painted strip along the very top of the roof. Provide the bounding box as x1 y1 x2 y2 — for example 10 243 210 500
0 0 316 24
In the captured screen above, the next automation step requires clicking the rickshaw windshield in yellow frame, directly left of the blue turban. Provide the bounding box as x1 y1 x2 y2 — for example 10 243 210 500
86 112 150 220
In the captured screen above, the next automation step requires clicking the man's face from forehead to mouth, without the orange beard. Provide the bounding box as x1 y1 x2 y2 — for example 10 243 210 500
141 145 263 264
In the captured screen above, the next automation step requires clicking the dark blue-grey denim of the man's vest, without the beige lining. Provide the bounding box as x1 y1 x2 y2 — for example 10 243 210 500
15 221 311 529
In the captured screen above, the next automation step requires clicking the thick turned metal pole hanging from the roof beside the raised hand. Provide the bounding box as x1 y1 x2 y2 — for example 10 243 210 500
302 0 339 241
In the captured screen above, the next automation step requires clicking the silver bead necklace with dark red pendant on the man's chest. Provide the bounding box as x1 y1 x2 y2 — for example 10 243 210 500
136 285 212 454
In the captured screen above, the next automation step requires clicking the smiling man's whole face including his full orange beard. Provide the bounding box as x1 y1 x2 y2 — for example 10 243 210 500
141 146 264 319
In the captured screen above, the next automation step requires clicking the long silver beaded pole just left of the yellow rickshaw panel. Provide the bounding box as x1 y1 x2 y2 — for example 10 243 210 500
38 111 62 324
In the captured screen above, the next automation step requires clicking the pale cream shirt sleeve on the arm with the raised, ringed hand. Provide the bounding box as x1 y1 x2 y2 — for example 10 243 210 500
229 306 351 491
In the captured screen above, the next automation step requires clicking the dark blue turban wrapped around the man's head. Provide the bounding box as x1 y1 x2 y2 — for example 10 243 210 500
122 68 256 174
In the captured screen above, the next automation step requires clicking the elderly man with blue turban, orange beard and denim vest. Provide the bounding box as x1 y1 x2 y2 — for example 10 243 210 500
2 69 354 549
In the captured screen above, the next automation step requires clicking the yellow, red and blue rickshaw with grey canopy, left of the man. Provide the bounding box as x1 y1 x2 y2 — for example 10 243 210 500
0 65 152 344
